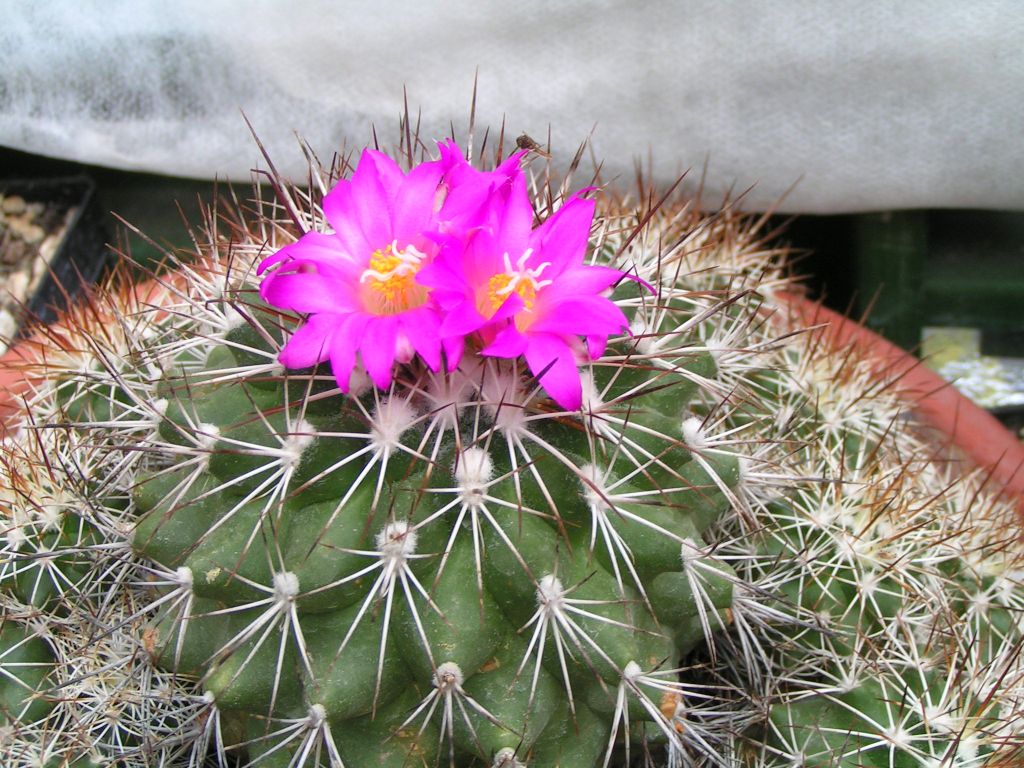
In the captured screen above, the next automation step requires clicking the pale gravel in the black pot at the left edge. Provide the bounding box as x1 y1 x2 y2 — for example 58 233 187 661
0 190 77 351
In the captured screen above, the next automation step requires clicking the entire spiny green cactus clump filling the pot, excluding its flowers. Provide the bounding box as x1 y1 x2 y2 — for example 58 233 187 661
0 129 1024 768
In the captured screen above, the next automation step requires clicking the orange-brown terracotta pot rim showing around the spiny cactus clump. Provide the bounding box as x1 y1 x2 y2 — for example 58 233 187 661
0 278 1024 513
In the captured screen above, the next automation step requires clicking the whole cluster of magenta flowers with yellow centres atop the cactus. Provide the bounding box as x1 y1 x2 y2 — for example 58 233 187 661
259 141 628 411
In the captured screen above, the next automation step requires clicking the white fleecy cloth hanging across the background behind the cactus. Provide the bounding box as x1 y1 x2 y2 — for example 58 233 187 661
0 0 1024 212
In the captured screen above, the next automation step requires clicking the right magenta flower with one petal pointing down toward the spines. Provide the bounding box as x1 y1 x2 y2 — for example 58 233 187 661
419 168 629 411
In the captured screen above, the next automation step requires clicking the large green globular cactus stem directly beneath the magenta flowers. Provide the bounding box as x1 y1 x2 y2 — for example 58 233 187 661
125 296 738 765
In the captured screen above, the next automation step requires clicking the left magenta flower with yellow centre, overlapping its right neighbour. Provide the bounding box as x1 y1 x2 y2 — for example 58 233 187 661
259 150 460 392
